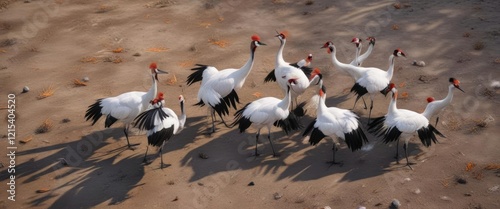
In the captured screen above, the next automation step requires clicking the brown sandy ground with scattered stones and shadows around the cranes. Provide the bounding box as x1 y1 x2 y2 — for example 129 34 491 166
0 0 500 208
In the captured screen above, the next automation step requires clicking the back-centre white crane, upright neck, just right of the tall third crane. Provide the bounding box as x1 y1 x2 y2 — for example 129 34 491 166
264 33 312 109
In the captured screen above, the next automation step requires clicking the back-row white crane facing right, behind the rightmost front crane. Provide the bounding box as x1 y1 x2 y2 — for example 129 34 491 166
351 49 406 122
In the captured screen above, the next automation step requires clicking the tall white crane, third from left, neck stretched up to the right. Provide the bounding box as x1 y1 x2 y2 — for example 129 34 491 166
186 35 266 133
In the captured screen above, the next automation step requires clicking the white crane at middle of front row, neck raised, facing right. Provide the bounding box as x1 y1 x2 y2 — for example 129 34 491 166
231 78 300 157
